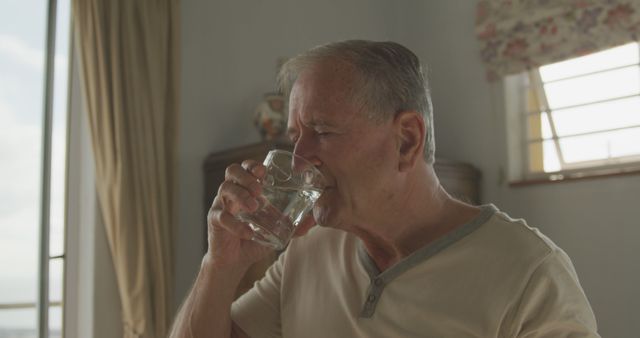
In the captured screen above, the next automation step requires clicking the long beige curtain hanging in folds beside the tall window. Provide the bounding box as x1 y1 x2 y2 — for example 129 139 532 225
73 0 179 338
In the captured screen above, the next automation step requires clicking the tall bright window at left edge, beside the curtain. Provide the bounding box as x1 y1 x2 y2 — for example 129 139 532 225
0 0 71 338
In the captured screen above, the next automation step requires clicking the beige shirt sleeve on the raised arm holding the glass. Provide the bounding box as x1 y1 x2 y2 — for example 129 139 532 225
231 252 286 338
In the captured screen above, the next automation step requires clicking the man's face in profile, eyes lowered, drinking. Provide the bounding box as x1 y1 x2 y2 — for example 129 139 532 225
288 62 398 230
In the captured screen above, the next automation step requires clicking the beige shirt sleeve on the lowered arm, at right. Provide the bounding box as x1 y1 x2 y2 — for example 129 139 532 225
505 249 600 338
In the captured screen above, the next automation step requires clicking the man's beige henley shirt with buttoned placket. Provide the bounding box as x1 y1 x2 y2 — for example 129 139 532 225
232 205 598 338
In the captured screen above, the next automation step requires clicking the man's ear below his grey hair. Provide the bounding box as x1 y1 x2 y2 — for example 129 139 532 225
393 111 426 171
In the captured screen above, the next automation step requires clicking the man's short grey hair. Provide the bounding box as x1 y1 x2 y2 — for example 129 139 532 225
278 40 435 164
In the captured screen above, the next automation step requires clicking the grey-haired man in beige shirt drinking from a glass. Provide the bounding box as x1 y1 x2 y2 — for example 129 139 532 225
173 41 598 338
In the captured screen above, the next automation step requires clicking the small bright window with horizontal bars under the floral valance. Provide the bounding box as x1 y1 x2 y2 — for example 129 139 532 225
505 42 640 185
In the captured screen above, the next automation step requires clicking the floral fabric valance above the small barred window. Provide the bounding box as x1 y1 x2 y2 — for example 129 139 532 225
476 0 640 80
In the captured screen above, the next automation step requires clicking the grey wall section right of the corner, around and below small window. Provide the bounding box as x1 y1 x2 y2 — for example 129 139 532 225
396 0 640 338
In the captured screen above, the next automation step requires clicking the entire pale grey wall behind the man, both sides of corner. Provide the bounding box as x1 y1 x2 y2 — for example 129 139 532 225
176 0 640 338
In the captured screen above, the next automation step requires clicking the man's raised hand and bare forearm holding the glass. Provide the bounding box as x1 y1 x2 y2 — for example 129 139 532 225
170 161 271 338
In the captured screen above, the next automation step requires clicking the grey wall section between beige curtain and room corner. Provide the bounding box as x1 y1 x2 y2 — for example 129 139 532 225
175 0 394 306
